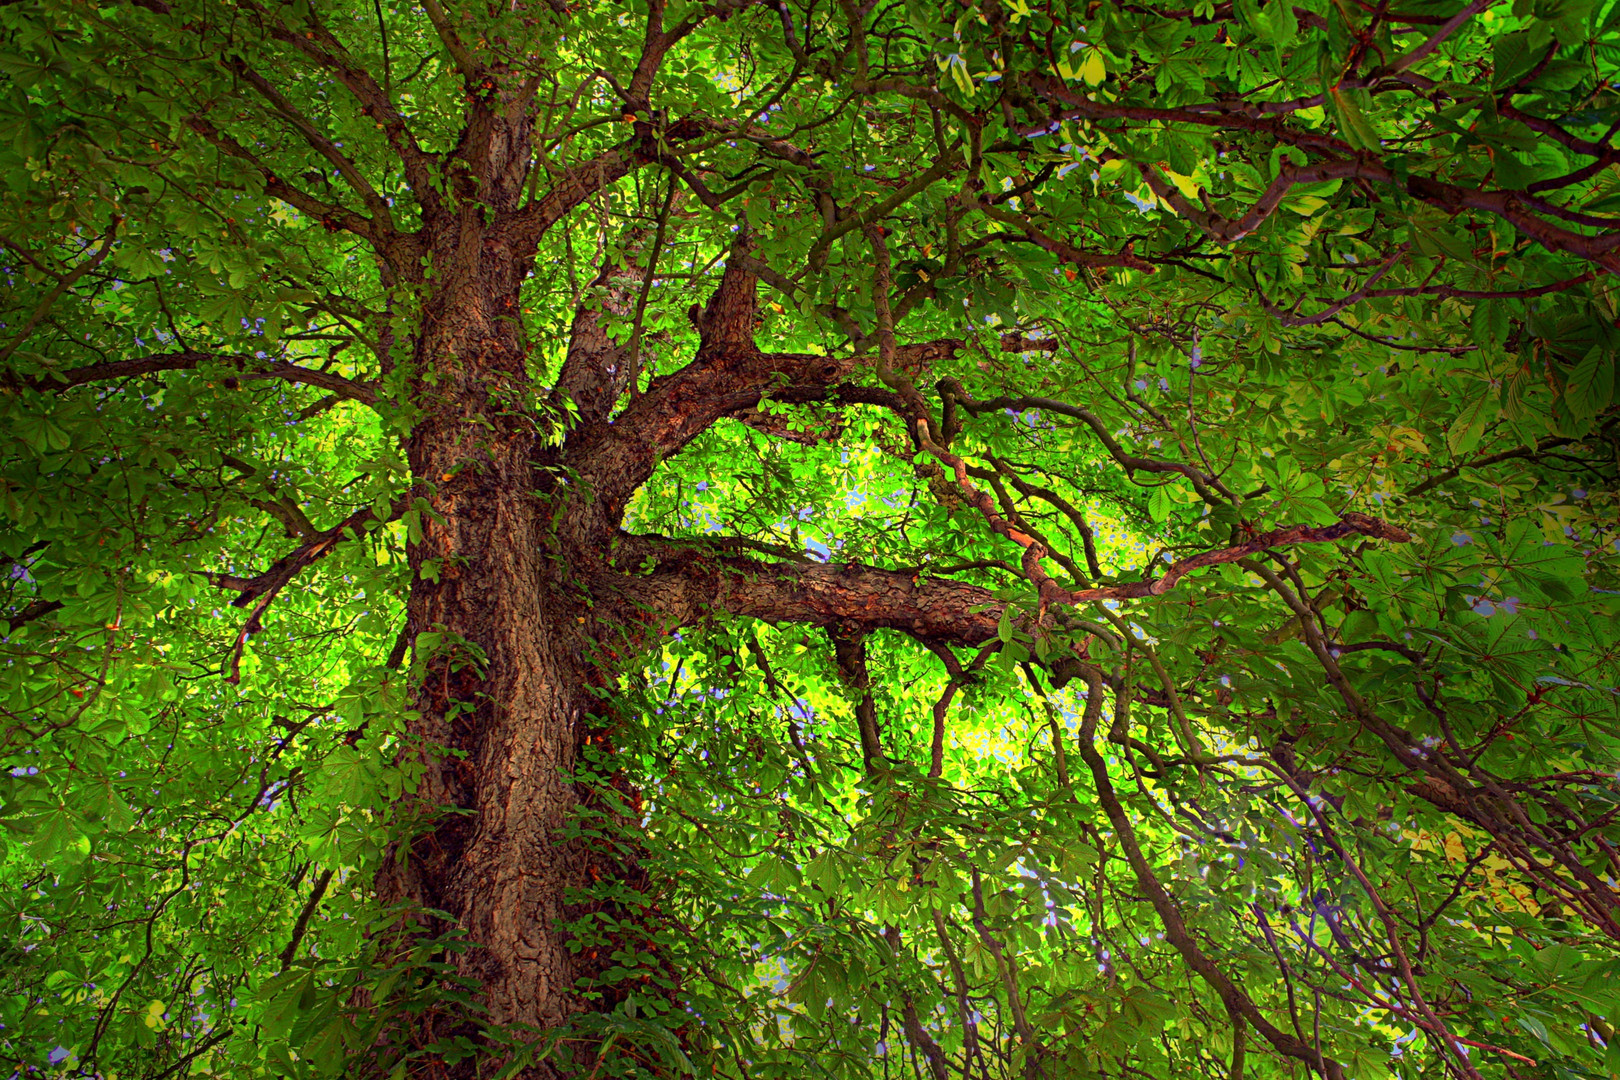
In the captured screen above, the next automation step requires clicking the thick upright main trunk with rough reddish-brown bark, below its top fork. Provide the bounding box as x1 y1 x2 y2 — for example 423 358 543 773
377 230 641 1075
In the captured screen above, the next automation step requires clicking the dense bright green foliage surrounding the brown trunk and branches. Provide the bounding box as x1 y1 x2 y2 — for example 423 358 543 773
0 0 1620 1080
